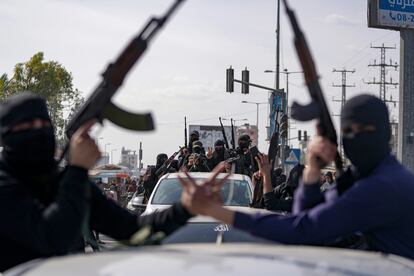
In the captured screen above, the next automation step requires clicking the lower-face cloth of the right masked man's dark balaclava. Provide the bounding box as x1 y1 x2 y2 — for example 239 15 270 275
342 132 389 177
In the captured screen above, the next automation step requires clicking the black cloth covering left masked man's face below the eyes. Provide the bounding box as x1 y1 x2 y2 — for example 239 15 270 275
2 128 56 179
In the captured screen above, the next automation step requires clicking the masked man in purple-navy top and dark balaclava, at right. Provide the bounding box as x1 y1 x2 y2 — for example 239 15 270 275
183 95 414 259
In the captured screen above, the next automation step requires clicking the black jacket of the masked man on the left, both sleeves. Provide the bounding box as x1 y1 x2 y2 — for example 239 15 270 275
0 162 191 271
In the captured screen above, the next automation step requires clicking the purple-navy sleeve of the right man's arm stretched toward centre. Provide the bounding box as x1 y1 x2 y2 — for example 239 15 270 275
234 179 402 245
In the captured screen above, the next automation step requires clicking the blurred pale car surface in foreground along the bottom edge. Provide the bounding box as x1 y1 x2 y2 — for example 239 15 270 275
5 244 414 276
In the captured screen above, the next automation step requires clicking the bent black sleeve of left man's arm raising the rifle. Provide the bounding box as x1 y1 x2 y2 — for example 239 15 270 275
0 166 90 255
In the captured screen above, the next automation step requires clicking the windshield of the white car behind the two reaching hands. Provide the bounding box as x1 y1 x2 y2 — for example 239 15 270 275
151 178 252 207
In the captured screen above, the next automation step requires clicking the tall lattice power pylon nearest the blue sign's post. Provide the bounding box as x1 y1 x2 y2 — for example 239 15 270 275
366 44 398 104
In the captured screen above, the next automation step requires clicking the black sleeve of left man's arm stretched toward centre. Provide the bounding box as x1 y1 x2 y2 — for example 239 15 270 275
91 185 192 240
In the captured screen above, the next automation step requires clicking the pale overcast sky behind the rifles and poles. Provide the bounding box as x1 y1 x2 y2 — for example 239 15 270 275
0 0 399 165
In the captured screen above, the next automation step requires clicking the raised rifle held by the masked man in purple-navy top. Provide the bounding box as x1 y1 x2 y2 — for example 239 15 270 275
283 0 343 175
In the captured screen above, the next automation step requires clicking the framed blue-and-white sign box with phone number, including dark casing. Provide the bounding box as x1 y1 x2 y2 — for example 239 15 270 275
368 0 414 30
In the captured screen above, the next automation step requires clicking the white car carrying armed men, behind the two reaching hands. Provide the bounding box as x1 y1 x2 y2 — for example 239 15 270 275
143 172 253 215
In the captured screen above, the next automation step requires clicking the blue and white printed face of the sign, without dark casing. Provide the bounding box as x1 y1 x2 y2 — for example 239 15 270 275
378 0 414 28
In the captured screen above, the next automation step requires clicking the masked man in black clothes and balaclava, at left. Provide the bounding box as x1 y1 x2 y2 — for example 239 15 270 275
0 93 191 271
